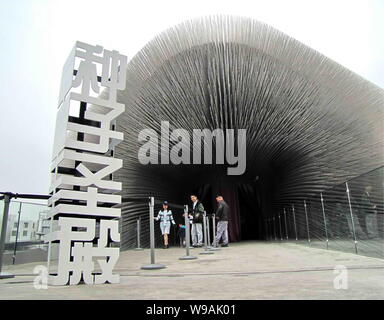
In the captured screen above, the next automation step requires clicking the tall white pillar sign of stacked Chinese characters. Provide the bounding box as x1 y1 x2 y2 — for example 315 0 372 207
45 42 127 285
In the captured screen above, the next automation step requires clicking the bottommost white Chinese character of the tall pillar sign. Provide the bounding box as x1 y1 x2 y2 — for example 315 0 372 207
46 217 120 285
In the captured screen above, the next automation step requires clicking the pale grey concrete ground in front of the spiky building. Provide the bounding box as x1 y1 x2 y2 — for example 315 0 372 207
0 242 384 300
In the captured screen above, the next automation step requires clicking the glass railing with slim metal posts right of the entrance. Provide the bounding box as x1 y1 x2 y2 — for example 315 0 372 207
266 167 384 258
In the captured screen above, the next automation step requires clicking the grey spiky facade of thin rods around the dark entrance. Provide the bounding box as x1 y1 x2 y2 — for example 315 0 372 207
116 16 384 248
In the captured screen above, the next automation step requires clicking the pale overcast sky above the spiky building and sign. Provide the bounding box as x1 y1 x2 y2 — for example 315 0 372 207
0 0 384 194
